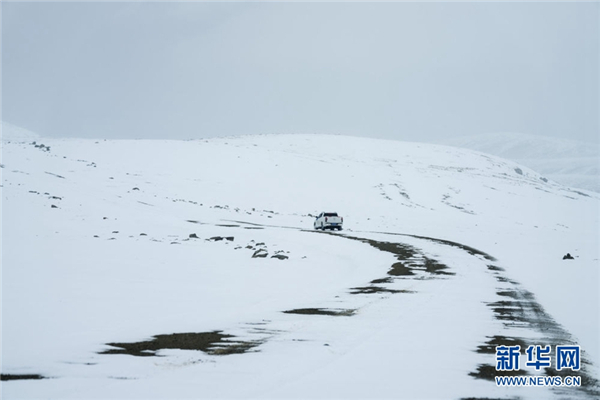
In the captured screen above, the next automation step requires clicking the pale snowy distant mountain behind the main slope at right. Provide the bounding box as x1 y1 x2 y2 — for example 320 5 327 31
439 133 600 192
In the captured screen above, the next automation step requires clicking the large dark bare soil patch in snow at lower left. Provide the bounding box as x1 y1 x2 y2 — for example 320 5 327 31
99 331 261 357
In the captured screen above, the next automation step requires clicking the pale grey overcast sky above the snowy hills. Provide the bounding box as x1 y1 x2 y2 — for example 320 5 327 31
1 2 600 142
